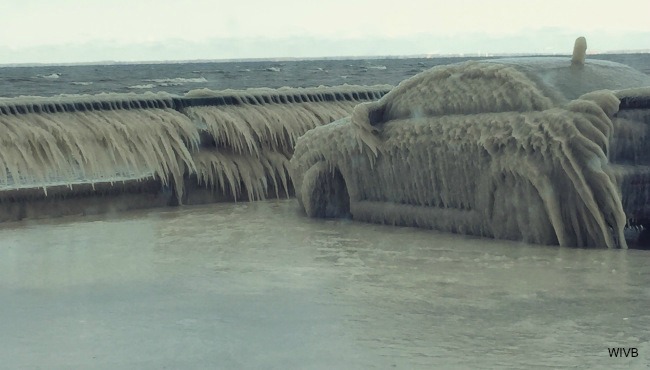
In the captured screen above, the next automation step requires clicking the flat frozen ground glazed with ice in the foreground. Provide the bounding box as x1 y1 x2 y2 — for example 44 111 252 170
0 200 650 369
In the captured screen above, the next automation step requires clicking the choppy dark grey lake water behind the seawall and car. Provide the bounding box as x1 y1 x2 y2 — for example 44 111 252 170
0 53 650 97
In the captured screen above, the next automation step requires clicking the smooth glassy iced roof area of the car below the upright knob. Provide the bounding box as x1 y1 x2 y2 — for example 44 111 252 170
484 57 650 100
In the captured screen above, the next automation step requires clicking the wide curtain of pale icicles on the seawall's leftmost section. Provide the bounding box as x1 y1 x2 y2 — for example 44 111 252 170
0 109 199 199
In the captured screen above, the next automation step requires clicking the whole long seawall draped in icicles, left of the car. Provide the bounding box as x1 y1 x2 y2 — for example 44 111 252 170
0 86 390 220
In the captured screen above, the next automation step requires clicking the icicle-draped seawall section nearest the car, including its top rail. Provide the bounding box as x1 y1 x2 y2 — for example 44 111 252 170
184 85 387 200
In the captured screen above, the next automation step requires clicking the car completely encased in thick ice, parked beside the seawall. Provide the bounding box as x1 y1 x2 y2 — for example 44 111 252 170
291 49 650 248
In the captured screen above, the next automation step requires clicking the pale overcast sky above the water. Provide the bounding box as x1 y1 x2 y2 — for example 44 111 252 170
0 0 650 63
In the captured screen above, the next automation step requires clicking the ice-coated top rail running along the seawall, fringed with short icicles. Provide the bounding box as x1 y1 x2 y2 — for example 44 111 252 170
0 85 392 115
